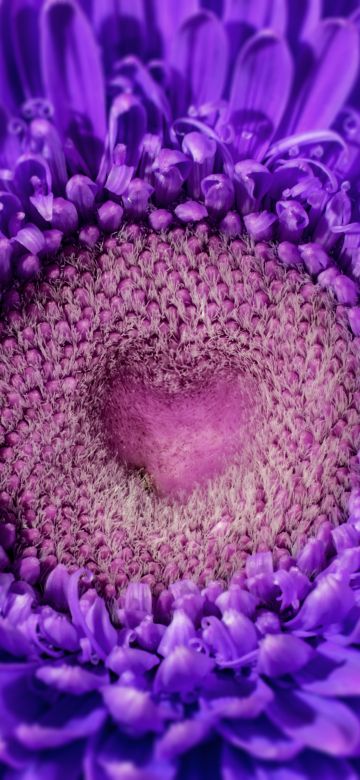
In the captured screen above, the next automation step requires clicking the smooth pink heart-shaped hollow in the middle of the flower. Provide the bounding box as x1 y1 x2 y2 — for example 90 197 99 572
105 371 253 496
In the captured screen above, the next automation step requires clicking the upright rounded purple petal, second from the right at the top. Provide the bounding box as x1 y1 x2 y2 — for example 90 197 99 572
228 31 293 159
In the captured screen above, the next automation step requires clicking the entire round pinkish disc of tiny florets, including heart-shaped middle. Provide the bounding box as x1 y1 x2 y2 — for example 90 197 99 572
0 226 360 594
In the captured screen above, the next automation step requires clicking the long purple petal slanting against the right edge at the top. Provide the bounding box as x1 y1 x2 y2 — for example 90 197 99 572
287 19 359 134
